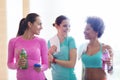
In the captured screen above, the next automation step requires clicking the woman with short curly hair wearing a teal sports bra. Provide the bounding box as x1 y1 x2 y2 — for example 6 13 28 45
81 17 113 80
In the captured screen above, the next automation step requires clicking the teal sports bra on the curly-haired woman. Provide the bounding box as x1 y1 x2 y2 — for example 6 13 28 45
81 44 102 68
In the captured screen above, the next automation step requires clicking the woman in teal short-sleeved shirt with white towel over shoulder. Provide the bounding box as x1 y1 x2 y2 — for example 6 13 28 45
48 15 77 80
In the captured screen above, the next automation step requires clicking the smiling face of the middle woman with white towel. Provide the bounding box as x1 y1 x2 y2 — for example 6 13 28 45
57 19 70 37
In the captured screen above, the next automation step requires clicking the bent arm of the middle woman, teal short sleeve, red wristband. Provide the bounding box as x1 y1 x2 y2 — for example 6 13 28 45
50 37 77 68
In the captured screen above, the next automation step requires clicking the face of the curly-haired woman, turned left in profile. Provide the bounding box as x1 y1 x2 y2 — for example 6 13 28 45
84 24 98 40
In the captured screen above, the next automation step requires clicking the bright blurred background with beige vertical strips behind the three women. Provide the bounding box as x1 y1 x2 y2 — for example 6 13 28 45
0 0 120 80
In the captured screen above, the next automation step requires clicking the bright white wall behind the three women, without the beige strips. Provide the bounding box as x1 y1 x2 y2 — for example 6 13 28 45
7 0 120 80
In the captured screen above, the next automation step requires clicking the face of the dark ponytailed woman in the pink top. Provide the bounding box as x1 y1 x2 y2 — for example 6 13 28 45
29 16 42 35
